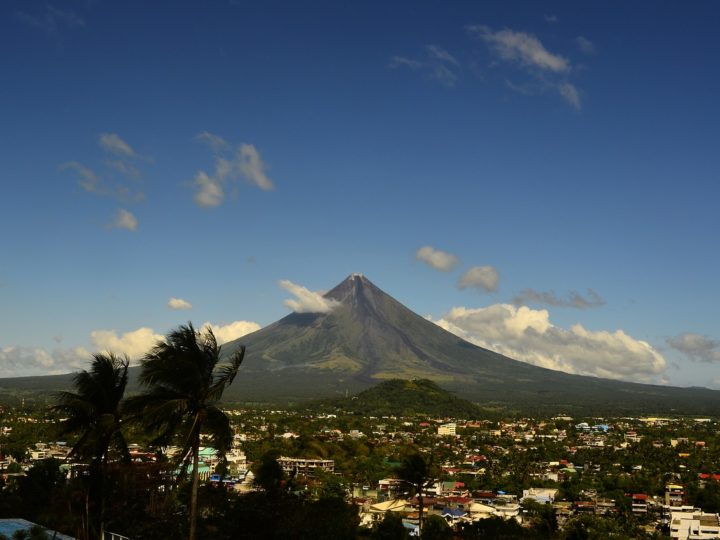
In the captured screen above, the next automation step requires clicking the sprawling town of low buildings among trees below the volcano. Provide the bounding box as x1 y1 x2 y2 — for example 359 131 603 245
0 398 720 539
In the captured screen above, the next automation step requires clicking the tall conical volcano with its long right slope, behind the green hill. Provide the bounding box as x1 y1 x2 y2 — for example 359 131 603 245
223 274 720 414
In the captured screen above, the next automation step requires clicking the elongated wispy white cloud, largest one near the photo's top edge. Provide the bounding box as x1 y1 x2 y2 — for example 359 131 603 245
468 25 570 73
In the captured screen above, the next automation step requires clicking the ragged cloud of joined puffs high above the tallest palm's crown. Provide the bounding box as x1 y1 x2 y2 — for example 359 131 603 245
192 131 275 208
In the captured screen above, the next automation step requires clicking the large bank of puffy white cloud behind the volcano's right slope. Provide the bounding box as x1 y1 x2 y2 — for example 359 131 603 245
435 304 667 383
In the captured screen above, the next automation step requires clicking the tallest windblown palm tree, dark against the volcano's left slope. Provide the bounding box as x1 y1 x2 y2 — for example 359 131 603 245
131 323 245 540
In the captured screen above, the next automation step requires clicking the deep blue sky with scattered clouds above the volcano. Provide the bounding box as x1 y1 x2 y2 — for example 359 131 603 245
0 0 720 388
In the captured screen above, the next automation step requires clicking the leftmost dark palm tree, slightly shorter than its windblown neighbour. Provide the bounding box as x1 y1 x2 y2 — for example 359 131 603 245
53 353 130 535
